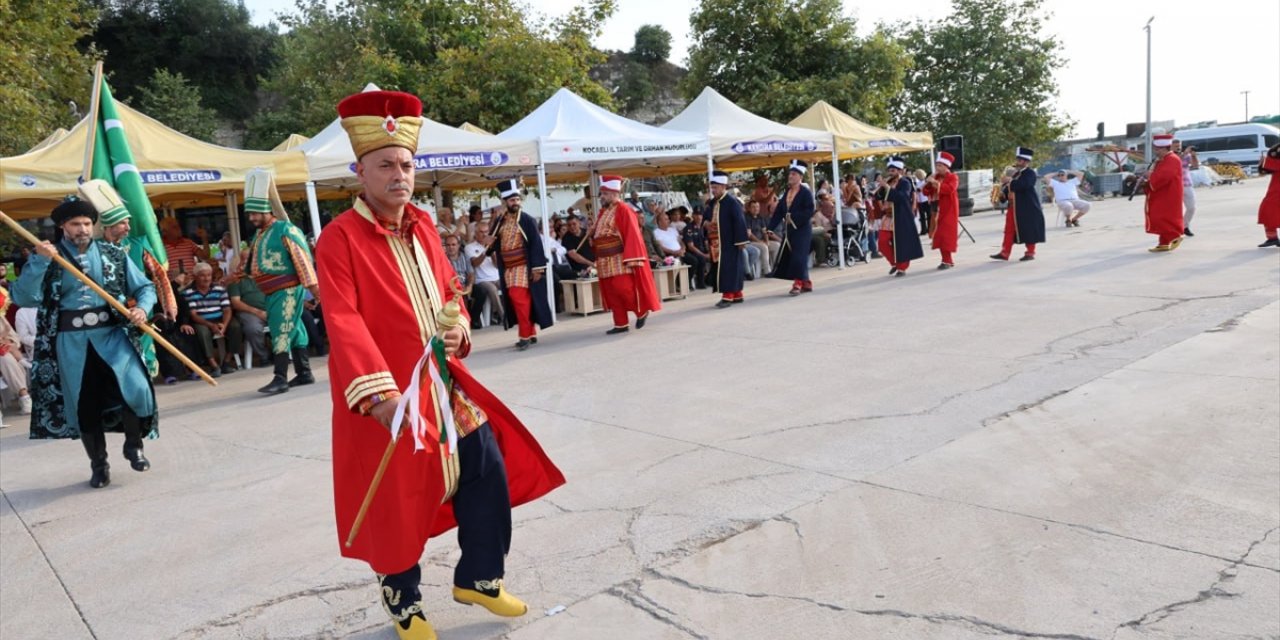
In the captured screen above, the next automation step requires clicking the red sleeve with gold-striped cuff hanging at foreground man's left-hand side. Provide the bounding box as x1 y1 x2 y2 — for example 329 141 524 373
316 224 399 412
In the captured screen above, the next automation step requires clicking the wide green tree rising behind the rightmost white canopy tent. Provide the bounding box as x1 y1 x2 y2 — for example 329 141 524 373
681 0 910 125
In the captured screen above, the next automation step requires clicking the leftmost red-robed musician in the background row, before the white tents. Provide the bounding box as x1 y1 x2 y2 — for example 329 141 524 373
591 175 662 335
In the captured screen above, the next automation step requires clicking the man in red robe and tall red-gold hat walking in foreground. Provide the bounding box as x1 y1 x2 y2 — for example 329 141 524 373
316 91 564 640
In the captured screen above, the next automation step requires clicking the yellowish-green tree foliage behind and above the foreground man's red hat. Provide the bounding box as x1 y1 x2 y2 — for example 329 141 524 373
248 0 614 147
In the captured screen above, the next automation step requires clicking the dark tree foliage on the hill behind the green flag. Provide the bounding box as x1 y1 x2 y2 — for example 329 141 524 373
93 0 279 120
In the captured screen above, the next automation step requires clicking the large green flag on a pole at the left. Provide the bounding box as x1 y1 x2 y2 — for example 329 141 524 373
90 78 169 269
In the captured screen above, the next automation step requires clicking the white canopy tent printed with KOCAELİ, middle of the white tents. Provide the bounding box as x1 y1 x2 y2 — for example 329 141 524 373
495 88 710 312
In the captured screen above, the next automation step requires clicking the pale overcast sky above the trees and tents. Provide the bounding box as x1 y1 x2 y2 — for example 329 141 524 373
244 0 1280 137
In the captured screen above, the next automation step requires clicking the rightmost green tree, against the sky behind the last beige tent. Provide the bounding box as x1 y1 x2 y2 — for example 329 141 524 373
893 0 1073 168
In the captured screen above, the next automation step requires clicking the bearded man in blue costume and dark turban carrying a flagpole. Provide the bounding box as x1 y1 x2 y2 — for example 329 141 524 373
13 198 157 489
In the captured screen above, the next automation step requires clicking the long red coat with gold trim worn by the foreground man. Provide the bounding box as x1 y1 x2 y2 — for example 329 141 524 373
316 200 564 573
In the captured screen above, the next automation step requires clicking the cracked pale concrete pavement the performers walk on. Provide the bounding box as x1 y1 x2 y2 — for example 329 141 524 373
0 180 1280 640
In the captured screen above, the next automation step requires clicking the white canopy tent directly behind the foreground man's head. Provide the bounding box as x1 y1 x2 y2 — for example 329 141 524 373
297 83 538 236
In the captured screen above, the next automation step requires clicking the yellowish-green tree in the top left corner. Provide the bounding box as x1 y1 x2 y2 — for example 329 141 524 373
0 0 97 156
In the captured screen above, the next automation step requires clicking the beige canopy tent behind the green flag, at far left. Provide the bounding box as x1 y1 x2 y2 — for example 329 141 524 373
0 104 307 220
